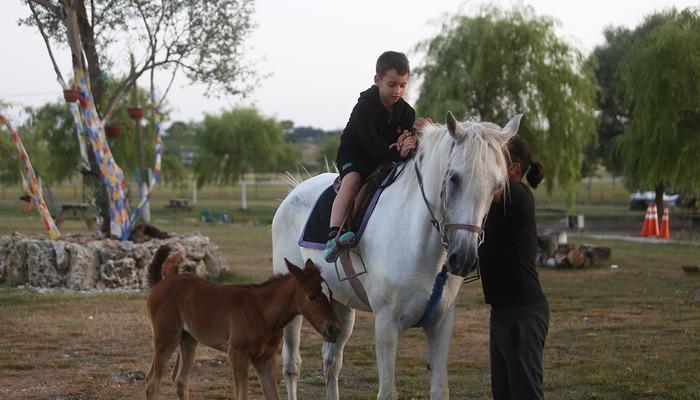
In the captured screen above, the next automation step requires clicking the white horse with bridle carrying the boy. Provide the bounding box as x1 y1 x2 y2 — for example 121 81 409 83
272 112 520 400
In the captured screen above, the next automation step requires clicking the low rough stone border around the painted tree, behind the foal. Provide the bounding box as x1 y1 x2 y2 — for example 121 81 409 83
0 232 228 290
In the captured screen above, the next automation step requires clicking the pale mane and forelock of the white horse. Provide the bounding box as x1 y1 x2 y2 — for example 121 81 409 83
408 120 512 195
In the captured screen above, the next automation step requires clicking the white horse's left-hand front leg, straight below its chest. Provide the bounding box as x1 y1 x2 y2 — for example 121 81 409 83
374 314 399 400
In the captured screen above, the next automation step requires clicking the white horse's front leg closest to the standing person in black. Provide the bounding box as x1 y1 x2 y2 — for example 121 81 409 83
425 302 455 400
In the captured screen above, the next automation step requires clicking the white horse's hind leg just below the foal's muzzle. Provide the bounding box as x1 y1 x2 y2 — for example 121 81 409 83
323 300 355 400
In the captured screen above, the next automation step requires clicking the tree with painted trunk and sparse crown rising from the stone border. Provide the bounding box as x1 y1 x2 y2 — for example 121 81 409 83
23 0 252 240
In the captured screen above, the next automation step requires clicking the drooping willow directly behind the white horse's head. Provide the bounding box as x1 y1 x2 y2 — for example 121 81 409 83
416 7 596 211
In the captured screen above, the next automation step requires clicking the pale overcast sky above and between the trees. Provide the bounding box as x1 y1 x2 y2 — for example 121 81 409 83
0 0 700 130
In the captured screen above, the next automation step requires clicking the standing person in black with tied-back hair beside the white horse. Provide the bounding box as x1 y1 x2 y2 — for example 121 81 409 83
479 136 549 400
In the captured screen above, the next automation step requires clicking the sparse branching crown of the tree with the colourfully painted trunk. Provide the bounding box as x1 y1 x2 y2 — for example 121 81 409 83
20 0 254 118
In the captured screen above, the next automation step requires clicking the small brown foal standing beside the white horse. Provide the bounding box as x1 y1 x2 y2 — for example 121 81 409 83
146 245 340 400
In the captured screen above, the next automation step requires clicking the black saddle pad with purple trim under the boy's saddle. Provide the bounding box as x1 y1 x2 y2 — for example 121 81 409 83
298 165 401 250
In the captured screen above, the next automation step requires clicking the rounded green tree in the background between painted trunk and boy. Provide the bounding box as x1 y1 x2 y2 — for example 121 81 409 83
194 108 300 208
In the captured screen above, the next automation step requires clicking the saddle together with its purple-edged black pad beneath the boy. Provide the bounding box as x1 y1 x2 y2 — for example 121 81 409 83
298 163 404 250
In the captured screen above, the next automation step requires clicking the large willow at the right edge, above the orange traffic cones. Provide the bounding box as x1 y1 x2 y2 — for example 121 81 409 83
616 9 700 219
